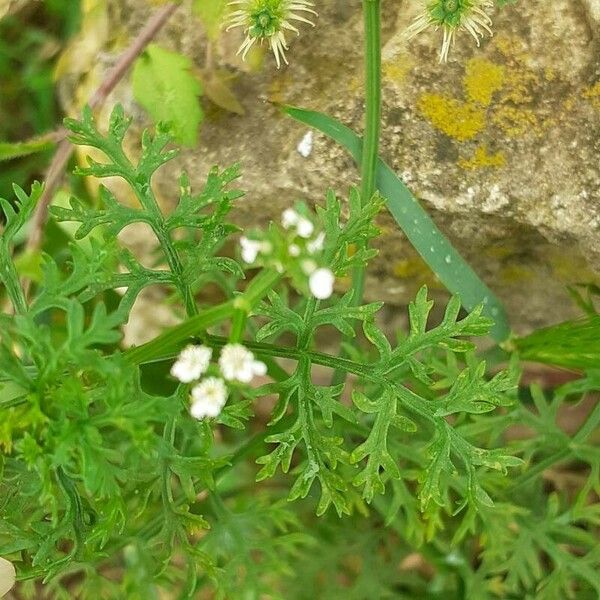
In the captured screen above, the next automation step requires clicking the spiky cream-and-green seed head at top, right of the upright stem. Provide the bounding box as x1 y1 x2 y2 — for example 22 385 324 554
406 0 494 62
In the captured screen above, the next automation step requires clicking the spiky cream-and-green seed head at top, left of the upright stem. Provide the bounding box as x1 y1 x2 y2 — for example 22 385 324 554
227 0 317 68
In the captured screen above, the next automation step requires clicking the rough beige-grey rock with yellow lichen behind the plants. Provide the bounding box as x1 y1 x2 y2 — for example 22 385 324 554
65 0 600 332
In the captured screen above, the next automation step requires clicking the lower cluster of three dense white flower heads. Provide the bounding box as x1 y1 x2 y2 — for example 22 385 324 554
171 344 267 419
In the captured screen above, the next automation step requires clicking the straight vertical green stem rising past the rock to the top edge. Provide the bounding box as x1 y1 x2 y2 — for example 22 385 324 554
332 0 381 385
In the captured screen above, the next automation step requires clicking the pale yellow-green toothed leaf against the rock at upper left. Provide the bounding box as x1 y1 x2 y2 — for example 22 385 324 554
133 44 203 146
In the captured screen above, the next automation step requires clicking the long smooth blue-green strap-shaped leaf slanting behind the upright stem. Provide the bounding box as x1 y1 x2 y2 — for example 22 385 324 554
283 106 510 341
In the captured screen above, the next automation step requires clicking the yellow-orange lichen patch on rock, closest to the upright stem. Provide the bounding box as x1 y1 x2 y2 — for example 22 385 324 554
417 94 485 141
